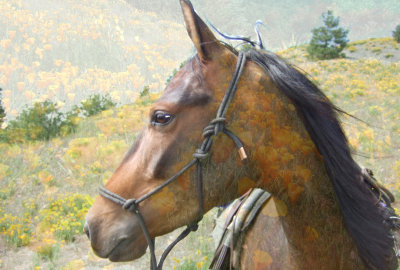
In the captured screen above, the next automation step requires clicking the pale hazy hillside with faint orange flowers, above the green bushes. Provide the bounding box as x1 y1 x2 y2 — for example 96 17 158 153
0 0 191 119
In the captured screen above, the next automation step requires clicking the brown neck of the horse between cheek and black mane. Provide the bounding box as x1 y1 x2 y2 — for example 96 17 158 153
232 64 360 263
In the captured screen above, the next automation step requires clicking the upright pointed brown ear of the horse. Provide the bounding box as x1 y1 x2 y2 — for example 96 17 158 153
180 0 222 60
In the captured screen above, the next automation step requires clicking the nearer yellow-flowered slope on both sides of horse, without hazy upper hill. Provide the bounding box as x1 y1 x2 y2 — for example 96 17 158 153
0 40 400 269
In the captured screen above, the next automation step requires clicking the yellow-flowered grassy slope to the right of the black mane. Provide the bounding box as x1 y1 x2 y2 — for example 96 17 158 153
281 38 400 188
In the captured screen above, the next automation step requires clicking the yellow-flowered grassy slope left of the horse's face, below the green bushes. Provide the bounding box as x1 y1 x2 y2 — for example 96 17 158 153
0 95 216 269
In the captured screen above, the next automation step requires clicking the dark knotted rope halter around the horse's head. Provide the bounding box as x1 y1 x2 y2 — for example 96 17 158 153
99 52 247 270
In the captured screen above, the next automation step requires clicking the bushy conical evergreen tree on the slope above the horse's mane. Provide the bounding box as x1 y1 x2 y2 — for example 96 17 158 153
307 10 349 59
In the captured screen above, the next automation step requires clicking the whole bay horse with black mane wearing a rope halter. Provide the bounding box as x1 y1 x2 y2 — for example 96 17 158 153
85 0 398 269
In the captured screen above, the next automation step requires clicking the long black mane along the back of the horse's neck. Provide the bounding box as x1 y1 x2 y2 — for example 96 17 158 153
247 49 397 269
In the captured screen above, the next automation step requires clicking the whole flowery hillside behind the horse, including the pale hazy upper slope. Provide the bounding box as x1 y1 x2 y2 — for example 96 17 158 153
0 0 400 269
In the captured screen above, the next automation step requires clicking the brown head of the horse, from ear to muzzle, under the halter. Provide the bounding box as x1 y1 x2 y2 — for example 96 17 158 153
85 0 260 261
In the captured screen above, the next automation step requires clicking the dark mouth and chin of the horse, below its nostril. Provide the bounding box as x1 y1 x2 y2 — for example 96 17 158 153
95 237 147 262
